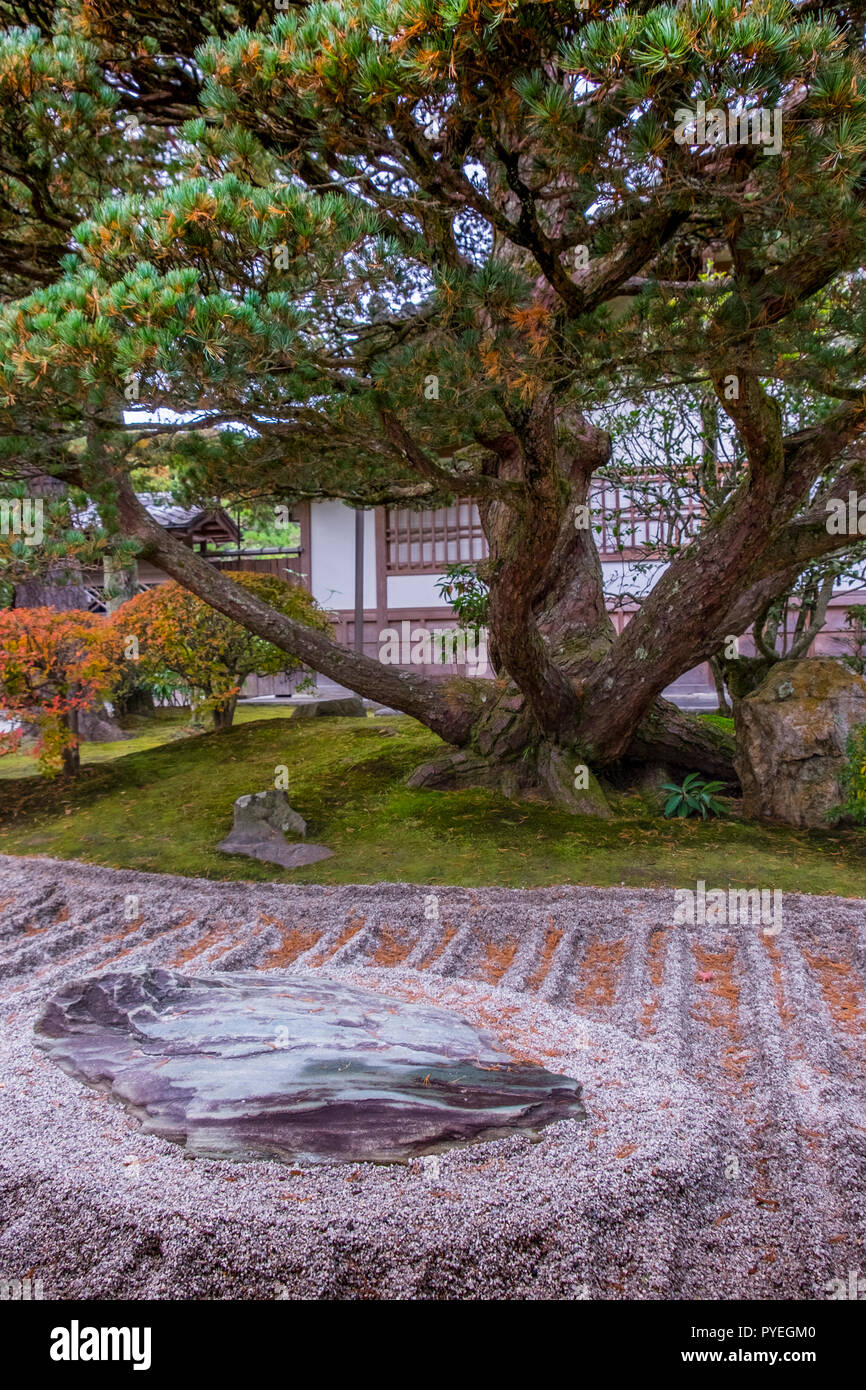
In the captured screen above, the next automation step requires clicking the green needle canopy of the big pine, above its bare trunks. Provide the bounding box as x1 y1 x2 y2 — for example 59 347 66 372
0 0 866 656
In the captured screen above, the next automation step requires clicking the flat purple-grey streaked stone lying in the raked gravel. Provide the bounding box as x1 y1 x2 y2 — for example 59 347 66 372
35 969 585 1163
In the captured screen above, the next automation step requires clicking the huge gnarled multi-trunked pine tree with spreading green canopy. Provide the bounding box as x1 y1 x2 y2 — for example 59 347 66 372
0 0 866 805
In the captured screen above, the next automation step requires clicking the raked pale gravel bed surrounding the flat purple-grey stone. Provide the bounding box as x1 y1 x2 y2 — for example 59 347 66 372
0 856 866 1300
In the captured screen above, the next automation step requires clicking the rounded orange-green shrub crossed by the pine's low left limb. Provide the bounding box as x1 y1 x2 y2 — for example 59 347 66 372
108 571 331 730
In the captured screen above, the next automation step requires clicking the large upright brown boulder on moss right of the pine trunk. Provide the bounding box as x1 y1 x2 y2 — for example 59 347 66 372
735 659 866 827
